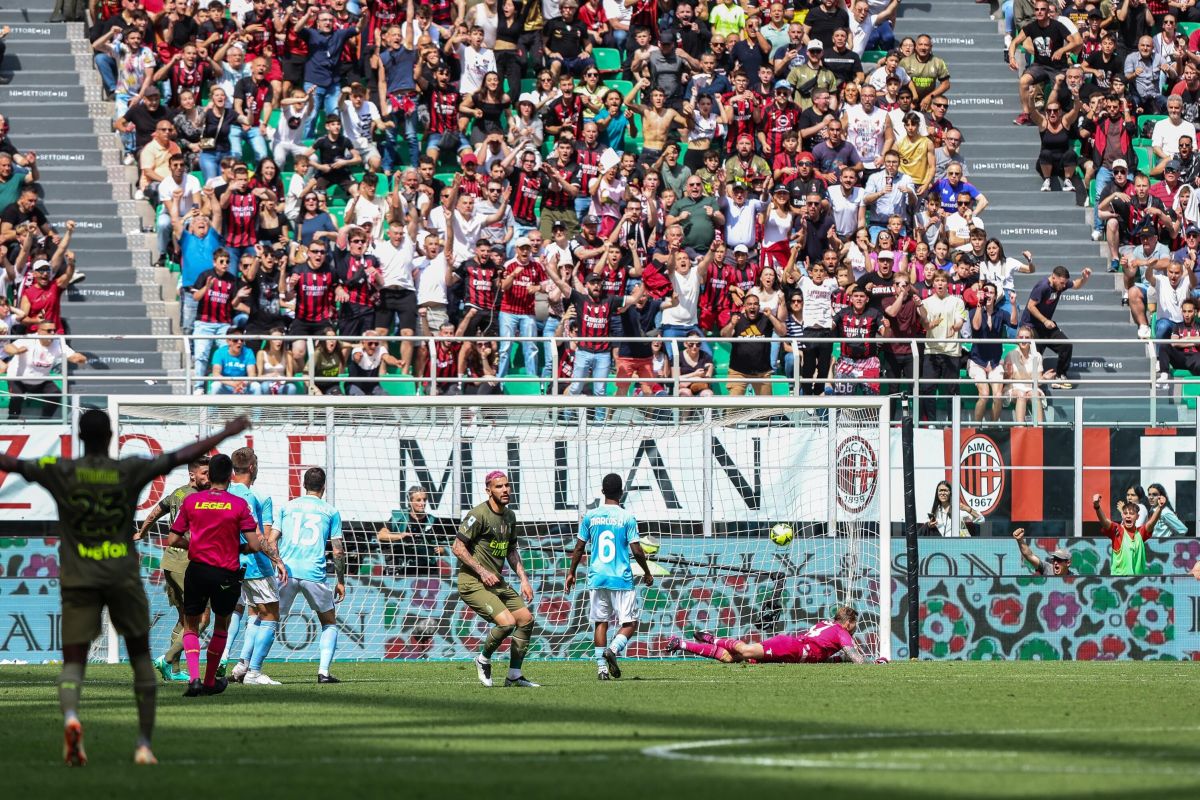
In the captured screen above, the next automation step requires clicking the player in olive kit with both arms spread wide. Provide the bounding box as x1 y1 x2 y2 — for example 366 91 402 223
0 409 250 766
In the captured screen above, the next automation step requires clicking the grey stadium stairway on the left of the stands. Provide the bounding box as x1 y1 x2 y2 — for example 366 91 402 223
0 7 178 395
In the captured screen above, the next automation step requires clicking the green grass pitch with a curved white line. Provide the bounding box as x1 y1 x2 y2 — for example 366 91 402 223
0 661 1200 800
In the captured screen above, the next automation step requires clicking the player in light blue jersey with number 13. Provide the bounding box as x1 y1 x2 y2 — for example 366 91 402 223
280 467 346 684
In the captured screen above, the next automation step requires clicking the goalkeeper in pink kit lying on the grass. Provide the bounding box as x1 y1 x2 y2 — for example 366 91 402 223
667 606 866 664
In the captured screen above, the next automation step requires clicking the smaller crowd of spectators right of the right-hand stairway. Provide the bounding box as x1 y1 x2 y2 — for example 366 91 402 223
1004 0 1200 387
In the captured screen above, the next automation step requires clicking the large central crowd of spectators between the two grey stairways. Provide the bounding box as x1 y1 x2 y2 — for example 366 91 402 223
72 0 1123 412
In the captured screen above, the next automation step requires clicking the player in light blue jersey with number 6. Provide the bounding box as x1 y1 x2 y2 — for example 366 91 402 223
566 473 654 680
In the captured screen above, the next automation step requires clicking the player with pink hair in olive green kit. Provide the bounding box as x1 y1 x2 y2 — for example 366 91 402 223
452 470 538 688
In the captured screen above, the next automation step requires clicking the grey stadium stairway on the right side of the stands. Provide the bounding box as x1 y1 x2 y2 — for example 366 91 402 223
898 0 1165 419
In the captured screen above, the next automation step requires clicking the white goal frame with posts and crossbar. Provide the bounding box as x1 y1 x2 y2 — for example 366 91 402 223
106 395 893 662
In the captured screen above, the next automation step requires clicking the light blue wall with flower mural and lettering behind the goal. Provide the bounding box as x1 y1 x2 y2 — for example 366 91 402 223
0 537 1200 662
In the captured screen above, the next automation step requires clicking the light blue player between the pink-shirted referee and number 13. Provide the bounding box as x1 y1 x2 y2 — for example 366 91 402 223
226 447 287 686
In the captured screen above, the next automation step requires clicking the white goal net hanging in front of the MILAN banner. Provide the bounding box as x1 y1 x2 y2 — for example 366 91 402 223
108 396 890 661
